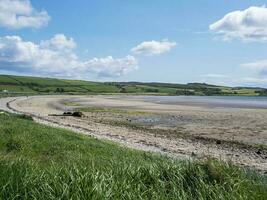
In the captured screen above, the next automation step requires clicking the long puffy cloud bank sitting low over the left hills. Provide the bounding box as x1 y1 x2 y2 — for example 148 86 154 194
0 34 138 78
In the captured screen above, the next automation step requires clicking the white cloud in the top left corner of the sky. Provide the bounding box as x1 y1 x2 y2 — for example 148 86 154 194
0 0 50 29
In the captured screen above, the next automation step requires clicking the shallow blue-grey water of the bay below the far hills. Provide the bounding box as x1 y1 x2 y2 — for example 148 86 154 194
126 96 267 109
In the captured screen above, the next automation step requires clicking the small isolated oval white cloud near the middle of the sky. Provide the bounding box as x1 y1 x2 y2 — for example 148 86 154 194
131 40 176 55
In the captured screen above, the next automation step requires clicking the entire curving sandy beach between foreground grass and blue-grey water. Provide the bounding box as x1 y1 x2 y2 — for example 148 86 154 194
3 96 267 171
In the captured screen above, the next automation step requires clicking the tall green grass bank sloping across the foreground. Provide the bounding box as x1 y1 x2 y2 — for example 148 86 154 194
0 113 267 200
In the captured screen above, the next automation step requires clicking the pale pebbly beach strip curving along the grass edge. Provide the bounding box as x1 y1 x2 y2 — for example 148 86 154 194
2 97 267 171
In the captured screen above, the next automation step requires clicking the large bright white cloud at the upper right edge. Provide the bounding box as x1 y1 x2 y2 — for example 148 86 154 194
209 6 267 41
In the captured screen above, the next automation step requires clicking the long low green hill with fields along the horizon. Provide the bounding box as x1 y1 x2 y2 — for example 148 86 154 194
0 75 267 96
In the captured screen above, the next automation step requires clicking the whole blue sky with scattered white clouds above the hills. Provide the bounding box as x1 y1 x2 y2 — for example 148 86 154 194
0 0 267 87
